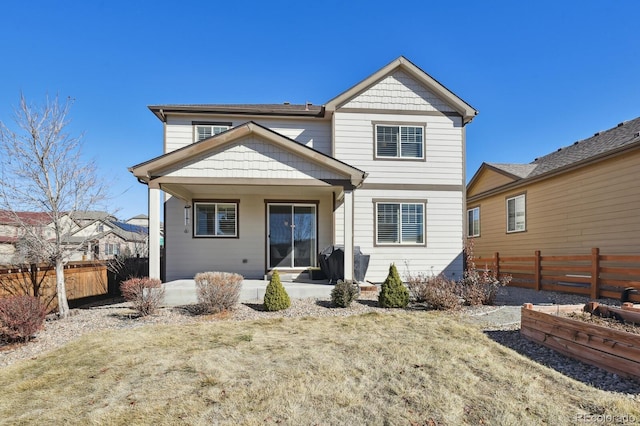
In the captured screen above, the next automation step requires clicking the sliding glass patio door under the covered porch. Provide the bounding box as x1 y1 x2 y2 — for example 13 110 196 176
267 203 317 269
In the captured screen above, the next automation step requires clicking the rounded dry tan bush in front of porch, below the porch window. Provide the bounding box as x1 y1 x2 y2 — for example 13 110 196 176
194 272 243 314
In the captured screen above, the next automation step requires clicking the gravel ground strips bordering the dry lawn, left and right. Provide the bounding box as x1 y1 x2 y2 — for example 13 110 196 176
0 287 640 402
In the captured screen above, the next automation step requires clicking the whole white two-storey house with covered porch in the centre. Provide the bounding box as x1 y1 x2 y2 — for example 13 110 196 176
130 57 477 282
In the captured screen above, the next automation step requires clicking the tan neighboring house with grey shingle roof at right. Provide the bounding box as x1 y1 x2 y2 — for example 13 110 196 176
467 118 640 256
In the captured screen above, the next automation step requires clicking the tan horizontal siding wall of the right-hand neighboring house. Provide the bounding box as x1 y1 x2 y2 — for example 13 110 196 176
467 150 640 256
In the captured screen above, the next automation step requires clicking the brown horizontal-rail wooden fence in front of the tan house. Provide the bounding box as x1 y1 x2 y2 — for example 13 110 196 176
474 248 640 302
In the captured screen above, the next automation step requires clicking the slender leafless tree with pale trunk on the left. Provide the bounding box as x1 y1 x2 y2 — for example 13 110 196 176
0 95 107 318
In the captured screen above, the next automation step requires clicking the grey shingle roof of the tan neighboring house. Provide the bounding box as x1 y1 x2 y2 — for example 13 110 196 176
467 117 640 196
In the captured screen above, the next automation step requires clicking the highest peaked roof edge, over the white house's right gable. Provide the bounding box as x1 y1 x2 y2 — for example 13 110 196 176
325 56 478 124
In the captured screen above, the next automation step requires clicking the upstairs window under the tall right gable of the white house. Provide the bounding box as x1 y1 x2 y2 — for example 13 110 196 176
375 124 424 158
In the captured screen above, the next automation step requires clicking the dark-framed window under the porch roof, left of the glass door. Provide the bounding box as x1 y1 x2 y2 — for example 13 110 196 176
194 202 238 237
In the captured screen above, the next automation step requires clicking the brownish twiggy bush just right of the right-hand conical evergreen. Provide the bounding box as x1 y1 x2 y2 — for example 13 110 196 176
407 274 460 310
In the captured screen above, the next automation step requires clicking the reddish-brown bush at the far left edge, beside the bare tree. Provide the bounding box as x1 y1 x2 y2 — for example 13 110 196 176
0 296 46 342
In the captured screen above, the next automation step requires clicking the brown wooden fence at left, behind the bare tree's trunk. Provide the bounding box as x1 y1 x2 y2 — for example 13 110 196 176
0 261 108 311
